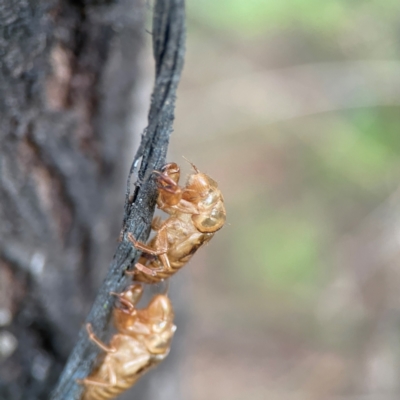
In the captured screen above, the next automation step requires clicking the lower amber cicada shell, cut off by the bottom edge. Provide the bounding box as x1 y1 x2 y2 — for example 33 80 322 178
80 285 176 400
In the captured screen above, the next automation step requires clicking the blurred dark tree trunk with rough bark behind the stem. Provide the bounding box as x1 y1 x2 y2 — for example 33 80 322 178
0 0 183 400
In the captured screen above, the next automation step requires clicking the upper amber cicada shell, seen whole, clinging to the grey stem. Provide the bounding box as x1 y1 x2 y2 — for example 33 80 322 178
127 163 226 283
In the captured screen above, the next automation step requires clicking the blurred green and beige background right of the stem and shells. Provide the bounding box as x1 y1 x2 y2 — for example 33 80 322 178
167 0 400 400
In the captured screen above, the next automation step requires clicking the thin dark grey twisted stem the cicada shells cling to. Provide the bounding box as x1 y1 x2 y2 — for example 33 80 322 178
51 0 185 400
